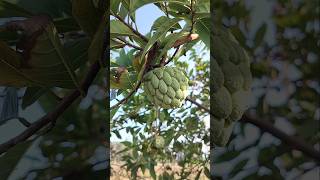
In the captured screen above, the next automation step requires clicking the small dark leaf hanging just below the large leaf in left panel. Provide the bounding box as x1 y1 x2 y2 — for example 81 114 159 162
22 87 48 109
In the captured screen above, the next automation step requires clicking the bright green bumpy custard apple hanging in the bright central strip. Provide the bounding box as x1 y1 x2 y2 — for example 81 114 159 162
144 67 188 109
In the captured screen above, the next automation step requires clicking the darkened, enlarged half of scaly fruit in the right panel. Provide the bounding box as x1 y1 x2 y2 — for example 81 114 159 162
210 22 252 146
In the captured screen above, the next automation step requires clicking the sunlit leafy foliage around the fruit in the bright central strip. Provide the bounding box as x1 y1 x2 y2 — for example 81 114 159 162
110 0 210 179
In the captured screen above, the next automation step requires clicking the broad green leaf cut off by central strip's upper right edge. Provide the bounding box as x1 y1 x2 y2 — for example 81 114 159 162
195 18 211 49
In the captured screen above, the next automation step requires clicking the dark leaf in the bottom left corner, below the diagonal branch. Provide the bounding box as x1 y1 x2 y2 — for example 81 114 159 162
0 141 32 179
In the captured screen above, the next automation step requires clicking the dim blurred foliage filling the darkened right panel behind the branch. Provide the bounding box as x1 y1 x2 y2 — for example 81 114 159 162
213 0 320 179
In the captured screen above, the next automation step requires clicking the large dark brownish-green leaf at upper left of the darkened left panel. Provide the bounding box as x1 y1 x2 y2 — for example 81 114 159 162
0 18 82 88
